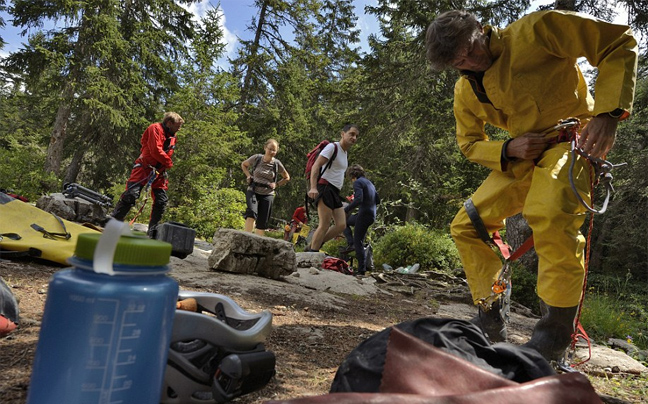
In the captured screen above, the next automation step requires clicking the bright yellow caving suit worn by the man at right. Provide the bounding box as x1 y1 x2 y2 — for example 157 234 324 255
451 11 637 307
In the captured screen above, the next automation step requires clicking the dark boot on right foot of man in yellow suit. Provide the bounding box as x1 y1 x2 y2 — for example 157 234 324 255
522 300 578 362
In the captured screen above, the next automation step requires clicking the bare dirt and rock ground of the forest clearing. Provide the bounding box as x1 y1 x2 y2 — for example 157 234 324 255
0 241 648 404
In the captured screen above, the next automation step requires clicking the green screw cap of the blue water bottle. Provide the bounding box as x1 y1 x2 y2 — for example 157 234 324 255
74 233 171 267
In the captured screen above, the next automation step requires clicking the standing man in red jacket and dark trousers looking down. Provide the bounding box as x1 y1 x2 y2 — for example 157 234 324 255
111 112 184 238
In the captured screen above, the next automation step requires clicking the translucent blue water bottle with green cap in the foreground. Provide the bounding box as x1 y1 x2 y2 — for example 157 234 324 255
27 220 178 404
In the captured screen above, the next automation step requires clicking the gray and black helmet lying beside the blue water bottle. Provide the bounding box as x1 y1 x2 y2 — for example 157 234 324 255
160 291 275 404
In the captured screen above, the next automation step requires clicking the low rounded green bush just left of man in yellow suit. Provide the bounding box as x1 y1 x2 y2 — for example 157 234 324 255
373 223 459 271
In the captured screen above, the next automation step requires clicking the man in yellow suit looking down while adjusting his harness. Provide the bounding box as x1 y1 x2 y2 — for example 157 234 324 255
426 10 637 360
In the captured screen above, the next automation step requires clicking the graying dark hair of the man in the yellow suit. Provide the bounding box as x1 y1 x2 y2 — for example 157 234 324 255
425 10 481 70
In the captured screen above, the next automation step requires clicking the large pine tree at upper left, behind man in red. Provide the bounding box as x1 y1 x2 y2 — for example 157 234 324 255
6 0 194 187
